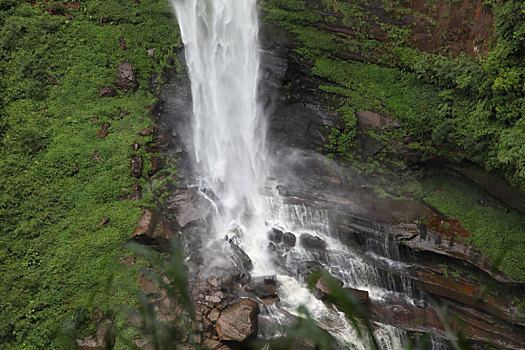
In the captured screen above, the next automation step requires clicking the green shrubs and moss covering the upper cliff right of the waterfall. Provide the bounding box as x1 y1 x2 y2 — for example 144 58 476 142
265 0 525 188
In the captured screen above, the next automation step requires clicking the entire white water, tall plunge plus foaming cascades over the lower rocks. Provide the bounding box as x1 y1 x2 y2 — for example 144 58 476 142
171 0 436 349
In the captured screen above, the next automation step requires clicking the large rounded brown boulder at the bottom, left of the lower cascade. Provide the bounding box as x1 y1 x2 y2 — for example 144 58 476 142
216 299 259 342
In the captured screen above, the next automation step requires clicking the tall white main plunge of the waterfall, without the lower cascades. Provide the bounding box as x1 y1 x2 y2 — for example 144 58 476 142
171 0 269 273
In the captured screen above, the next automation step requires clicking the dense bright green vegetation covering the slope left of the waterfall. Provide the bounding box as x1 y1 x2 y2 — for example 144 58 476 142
0 0 179 350
